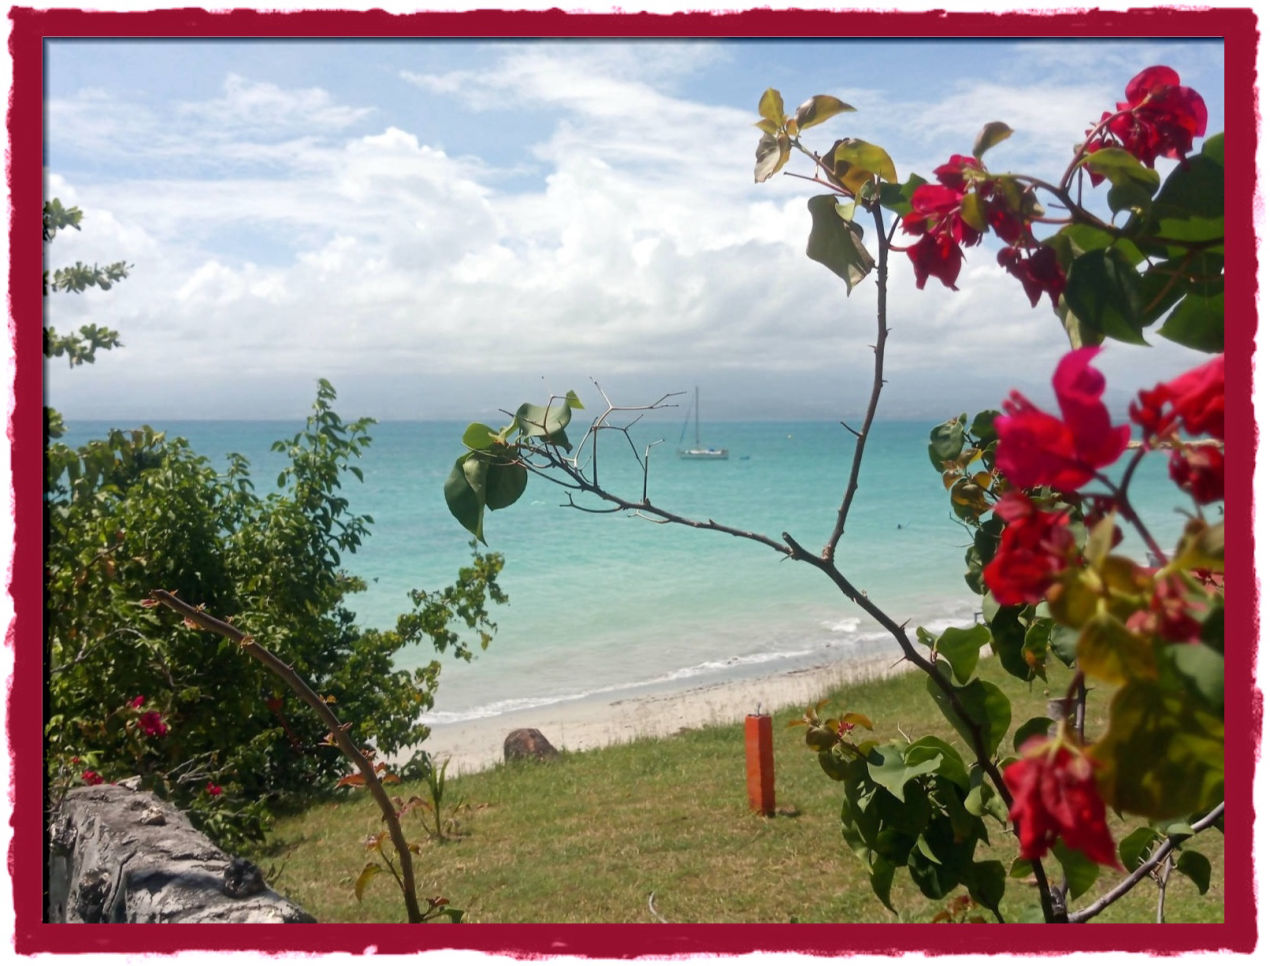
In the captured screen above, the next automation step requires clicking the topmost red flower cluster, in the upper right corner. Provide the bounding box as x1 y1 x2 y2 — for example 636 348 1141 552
1090 67 1208 170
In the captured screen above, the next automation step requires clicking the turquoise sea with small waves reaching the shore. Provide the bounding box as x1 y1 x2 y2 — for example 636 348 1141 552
64 420 1181 724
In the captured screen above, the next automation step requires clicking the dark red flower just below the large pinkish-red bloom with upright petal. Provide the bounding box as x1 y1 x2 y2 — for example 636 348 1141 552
983 493 1076 607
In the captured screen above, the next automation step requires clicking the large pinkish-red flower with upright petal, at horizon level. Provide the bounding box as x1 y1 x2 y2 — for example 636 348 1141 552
996 347 1129 491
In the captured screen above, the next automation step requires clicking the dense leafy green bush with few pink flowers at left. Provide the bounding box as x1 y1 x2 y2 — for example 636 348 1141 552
44 204 505 848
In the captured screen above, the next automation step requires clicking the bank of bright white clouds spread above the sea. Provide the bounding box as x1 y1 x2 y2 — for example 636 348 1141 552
50 44 1224 415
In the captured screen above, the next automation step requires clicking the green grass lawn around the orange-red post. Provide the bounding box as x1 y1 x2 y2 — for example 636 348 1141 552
258 661 1223 923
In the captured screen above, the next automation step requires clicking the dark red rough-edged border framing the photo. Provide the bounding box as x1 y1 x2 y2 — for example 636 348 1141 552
6 8 1261 958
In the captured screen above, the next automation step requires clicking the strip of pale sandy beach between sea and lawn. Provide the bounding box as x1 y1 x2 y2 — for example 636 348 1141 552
403 647 909 774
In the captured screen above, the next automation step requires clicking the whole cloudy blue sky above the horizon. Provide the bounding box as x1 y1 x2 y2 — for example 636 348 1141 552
44 33 1223 420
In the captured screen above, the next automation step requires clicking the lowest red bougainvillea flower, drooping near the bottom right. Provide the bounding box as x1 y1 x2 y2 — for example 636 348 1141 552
1001 735 1120 868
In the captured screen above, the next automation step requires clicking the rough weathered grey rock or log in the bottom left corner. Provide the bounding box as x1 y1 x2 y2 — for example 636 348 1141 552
47 784 316 923
